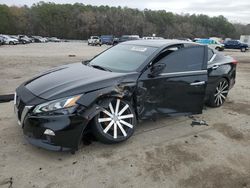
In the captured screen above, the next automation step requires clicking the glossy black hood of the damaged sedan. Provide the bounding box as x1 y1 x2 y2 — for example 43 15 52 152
24 63 128 100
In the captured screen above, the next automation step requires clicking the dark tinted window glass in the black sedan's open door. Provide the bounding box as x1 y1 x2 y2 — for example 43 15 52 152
157 46 207 73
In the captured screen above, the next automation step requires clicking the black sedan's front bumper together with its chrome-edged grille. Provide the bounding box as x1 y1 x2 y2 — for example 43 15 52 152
14 85 89 151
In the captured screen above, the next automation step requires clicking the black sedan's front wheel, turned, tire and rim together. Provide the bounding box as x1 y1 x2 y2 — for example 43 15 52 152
92 98 136 144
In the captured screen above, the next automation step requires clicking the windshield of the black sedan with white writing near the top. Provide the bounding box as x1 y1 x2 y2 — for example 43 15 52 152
89 45 157 72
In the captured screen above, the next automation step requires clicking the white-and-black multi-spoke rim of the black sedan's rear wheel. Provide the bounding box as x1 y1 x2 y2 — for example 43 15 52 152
214 80 229 106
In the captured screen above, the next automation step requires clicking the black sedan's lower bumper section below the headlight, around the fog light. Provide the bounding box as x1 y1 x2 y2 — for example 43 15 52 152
22 114 88 151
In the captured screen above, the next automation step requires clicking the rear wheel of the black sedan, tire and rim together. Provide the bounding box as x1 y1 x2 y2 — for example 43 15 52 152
207 78 229 107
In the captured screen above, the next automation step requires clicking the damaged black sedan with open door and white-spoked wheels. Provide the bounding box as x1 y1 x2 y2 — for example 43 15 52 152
14 40 237 151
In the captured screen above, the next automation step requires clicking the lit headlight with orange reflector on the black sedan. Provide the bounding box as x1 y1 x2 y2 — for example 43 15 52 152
33 95 82 114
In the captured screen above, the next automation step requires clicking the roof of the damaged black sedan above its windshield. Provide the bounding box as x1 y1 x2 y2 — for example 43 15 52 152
121 39 200 48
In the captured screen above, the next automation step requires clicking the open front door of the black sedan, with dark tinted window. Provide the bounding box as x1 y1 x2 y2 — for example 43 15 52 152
137 46 208 118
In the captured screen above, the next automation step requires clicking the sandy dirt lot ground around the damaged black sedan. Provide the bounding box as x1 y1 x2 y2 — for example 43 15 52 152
0 42 250 188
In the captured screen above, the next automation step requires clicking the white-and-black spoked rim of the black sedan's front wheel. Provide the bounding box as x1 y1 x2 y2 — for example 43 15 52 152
98 99 135 140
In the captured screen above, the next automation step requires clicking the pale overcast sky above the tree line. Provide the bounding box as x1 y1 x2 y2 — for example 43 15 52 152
0 0 250 24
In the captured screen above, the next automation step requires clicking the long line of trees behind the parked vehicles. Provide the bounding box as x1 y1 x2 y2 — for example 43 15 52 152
0 2 250 39
